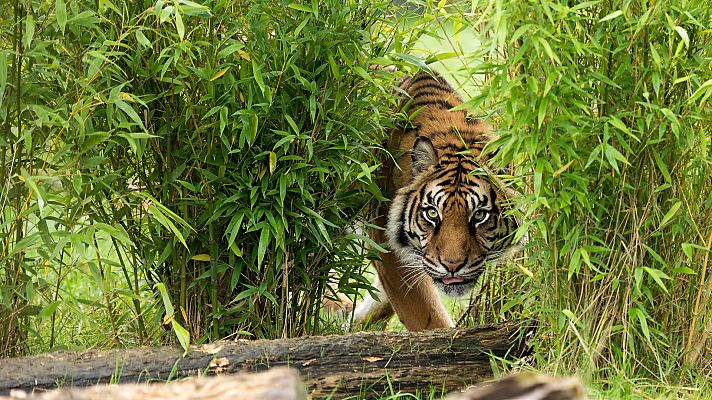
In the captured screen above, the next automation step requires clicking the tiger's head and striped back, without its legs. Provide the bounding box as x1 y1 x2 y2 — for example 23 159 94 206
387 72 518 296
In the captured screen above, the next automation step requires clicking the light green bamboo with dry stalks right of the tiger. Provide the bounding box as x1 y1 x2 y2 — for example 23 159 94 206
470 0 712 380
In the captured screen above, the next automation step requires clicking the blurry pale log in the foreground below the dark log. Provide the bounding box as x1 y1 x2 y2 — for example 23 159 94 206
0 367 307 400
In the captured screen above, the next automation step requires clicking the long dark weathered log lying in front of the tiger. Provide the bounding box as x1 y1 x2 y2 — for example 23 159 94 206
0 323 532 398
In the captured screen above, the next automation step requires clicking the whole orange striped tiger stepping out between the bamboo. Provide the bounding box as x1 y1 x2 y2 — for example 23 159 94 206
328 71 519 331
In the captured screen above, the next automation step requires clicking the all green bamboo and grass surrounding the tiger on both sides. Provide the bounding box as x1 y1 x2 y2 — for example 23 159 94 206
0 0 712 397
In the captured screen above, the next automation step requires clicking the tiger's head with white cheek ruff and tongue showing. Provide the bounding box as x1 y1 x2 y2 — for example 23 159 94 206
386 137 520 296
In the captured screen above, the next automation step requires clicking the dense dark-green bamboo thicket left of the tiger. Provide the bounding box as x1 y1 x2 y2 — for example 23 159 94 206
0 0 400 354
